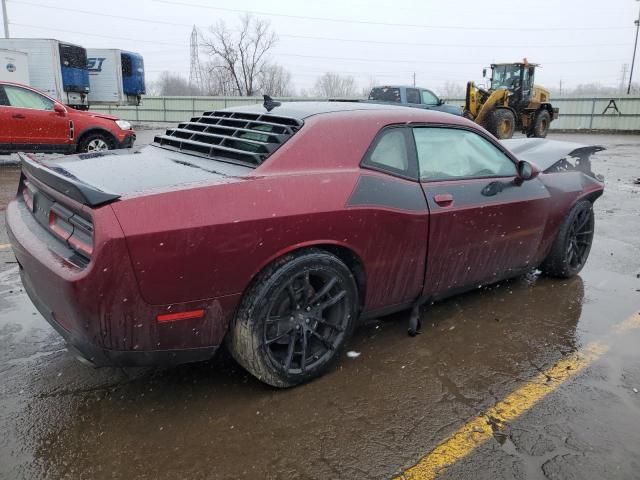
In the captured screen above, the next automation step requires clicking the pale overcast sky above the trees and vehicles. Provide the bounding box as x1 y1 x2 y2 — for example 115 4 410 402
0 0 640 91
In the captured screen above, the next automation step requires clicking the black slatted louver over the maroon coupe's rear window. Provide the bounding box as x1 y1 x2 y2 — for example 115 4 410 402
154 111 302 167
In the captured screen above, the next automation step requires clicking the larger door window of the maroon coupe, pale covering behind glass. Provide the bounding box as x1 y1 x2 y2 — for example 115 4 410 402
413 127 516 181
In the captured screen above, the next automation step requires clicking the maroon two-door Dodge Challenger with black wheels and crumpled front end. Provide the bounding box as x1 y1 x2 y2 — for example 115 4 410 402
7 102 604 387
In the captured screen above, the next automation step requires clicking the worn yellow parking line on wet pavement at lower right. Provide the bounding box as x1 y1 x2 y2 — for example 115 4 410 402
396 313 640 480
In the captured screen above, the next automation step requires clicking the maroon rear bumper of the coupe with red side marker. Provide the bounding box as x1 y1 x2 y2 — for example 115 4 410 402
7 195 238 366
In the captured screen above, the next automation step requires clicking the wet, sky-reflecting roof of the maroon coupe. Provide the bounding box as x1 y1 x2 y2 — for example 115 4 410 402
224 101 436 120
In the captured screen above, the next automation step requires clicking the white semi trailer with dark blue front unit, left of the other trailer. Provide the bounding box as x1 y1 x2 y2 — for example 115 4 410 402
0 38 89 110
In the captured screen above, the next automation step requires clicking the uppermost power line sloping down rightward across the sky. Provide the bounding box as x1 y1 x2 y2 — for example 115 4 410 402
153 0 630 32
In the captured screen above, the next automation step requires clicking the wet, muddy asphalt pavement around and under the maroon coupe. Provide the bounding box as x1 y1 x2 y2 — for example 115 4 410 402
0 131 640 480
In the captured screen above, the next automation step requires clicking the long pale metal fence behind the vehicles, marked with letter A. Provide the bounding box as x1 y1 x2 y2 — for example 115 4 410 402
91 96 640 132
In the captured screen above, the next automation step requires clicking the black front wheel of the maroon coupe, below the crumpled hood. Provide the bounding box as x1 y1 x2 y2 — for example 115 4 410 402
539 200 595 278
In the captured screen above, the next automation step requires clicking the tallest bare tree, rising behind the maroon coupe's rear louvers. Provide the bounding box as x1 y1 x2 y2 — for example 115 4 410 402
202 14 277 96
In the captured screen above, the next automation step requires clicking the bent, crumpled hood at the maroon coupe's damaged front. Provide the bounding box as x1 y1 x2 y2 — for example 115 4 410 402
501 138 605 172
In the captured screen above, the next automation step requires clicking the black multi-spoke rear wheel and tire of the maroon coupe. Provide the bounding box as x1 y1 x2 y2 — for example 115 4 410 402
227 249 358 388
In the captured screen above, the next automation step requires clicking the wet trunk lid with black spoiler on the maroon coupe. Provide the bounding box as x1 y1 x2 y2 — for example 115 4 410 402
20 145 253 206
